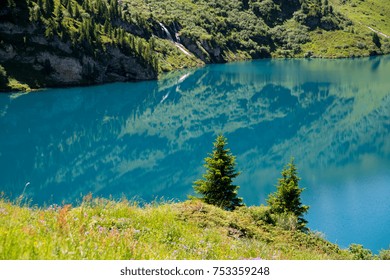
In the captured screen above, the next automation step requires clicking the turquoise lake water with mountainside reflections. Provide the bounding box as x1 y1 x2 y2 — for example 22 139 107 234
0 56 390 253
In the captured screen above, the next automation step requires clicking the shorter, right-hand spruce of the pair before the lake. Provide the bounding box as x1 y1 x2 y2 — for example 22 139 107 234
267 158 309 230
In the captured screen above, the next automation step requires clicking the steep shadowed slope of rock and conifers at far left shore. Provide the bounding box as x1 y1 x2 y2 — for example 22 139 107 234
0 0 157 91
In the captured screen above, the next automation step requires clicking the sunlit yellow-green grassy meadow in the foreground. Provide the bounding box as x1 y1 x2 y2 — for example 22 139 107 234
0 198 360 260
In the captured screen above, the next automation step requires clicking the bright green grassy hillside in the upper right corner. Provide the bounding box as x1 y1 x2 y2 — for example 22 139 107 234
302 0 390 58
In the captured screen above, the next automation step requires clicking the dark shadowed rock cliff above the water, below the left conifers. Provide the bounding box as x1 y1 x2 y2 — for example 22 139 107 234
0 22 157 91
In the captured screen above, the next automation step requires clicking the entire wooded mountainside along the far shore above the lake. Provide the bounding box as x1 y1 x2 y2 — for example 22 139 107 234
0 0 390 91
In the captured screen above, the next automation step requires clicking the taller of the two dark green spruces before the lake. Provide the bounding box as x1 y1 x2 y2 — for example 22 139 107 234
194 135 243 210
